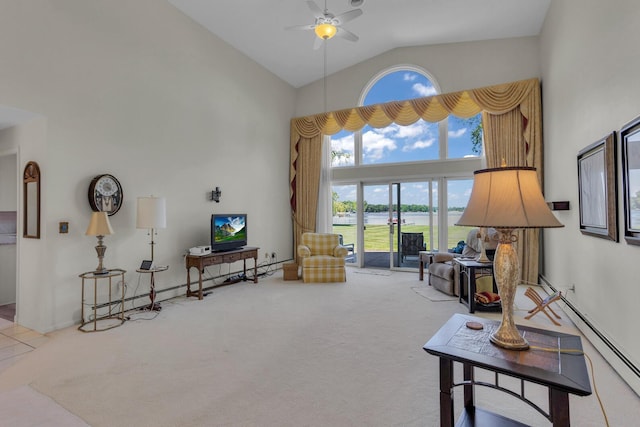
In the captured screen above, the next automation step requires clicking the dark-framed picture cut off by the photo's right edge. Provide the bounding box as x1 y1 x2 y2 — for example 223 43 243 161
620 117 640 245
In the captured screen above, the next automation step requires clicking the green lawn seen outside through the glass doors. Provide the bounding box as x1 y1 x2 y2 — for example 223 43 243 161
333 224 470 252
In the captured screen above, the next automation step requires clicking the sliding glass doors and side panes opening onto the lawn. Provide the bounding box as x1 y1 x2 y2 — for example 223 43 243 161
332 178 473 270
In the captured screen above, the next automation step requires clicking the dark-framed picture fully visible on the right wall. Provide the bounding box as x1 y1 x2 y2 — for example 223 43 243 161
578 132 616 242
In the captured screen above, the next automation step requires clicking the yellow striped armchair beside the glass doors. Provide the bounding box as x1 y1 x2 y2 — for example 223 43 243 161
298 233 347 283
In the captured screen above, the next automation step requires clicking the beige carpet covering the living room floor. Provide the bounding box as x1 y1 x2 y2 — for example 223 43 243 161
0 269 640 427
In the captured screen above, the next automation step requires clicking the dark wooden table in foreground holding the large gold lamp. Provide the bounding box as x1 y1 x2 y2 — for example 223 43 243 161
424 314 591 427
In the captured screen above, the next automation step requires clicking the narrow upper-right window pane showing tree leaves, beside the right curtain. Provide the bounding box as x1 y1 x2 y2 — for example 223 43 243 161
447 114 482 159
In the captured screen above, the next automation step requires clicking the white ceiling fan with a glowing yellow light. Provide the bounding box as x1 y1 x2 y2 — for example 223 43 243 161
285 0 362 49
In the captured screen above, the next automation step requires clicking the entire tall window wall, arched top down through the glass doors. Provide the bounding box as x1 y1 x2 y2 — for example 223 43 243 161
329 65 483 260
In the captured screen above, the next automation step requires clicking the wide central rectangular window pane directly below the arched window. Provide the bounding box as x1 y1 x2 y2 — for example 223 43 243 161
362 119 439 165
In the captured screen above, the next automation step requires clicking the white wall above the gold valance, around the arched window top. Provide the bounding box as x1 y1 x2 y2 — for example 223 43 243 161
295 37 540 117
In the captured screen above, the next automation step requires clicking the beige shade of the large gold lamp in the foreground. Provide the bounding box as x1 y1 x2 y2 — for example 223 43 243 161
456 167 564 229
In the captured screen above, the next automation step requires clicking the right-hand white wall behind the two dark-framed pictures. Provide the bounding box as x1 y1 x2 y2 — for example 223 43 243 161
540 0 640 392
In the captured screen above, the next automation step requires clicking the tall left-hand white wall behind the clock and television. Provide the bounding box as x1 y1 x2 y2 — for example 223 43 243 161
0 0 295 332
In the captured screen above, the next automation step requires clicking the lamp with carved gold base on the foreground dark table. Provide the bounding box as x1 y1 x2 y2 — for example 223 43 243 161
456 166 564 350
